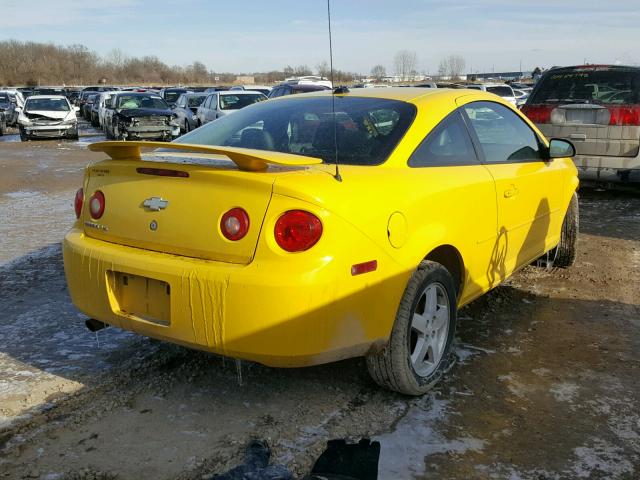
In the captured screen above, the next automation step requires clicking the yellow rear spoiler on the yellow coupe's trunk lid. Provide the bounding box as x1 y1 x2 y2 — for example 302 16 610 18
89 141 322 172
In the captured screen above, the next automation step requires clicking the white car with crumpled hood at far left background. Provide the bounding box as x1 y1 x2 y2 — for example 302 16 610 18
18 95 78 142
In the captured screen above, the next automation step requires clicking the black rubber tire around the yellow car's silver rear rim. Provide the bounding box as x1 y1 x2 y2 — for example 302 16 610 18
366 261 457 395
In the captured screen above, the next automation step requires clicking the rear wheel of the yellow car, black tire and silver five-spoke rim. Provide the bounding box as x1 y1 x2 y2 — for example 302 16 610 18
366 261 456 395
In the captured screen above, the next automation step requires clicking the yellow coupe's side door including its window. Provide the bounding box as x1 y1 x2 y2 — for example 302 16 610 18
462 101 563 275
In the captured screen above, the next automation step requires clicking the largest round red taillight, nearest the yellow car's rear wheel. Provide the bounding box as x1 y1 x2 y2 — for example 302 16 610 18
274 210 322 252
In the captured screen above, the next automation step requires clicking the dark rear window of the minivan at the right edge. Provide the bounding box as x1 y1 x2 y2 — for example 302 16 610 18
528 68 640 105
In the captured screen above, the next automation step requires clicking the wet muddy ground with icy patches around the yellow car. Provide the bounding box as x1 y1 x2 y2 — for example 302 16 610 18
0 124 640 480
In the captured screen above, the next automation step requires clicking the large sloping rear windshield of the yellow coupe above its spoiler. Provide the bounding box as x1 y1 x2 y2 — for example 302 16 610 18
176 96 416 165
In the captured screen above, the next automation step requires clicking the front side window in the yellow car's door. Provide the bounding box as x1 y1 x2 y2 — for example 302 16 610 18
464 102 541 163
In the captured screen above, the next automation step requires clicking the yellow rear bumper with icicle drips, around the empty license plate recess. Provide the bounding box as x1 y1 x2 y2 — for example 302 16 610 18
63 229 408 367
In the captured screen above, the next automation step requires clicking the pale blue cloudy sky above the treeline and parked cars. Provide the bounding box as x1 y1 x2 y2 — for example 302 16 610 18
0 0 640 73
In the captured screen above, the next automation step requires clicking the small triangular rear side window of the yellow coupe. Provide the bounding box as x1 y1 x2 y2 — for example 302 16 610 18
409 111 479 167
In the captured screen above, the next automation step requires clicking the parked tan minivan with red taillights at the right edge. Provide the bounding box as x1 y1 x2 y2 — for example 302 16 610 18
522 65 640 182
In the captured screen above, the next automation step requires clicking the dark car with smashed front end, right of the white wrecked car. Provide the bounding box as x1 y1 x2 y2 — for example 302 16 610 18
104 92 180 141
